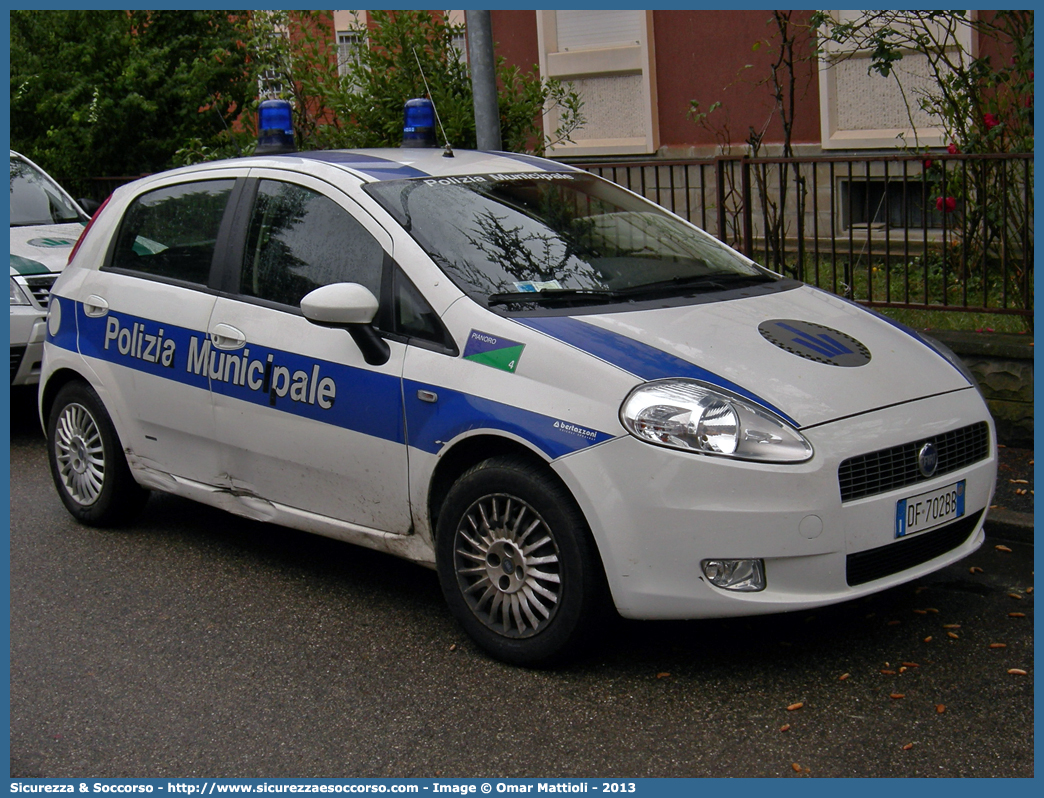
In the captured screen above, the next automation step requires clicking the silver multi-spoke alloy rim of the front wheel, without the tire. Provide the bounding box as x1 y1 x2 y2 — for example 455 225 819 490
453 494 563 638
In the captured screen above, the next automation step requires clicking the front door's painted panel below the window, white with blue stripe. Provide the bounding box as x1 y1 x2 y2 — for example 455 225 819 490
205 298 410 535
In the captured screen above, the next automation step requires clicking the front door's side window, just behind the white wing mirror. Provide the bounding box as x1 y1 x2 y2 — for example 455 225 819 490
239 181 384 307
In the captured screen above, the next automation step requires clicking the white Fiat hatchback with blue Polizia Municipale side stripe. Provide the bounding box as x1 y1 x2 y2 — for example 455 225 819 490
40 139 996 664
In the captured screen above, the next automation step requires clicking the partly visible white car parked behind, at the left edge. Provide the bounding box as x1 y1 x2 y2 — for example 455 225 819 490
10 150 88 385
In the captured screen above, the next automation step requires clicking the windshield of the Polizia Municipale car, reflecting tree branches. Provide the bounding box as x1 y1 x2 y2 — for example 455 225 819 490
365 172 776 305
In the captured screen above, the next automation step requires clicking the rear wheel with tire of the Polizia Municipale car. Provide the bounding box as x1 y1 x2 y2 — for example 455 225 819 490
47 382 148 526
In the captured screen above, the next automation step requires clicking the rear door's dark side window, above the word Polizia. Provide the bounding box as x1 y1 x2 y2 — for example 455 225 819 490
110 180 235 285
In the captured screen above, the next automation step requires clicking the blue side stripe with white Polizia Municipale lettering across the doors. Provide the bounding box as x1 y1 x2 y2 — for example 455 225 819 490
47 298 615 460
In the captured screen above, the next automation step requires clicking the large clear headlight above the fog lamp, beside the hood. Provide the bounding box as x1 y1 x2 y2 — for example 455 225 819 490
620 379 812 463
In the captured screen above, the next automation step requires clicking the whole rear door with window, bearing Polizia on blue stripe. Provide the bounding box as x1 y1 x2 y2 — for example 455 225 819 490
76 170 245 485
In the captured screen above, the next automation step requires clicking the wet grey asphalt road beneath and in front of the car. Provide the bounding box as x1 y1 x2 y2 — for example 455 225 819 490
10 392 1034 780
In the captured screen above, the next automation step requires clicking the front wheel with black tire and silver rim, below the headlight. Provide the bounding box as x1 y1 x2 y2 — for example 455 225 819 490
435 457 608 667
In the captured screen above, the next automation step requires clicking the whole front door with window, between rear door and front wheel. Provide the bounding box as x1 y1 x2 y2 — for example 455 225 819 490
209 170 410 534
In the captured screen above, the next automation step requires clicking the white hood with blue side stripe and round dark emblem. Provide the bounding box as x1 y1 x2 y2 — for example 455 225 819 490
523 285 970 427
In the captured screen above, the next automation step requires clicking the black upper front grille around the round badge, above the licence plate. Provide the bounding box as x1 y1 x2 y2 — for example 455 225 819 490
837 421 990 501
